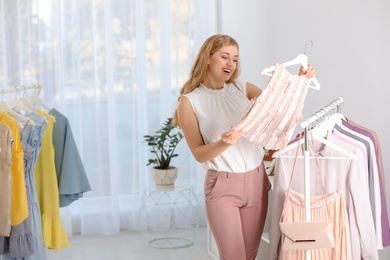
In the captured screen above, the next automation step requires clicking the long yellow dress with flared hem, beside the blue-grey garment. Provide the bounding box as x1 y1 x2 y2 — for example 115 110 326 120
34 109 70 250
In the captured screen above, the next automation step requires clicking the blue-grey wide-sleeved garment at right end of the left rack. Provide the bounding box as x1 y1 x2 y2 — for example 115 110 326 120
49 108 91 207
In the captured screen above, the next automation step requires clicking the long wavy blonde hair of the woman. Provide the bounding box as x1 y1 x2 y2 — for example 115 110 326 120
172 34 240 127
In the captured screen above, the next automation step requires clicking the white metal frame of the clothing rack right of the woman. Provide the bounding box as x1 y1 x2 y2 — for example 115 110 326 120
301 97 344 260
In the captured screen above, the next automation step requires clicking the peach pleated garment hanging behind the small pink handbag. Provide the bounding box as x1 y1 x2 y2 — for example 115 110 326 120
280 133 352 260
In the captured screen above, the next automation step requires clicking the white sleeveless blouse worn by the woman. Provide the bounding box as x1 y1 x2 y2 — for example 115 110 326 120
184 82 264 172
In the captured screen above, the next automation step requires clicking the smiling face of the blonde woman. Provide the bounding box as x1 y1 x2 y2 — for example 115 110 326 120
208 45 238 82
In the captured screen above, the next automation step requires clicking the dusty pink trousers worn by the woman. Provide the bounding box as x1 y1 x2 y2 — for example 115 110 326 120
204 164 271 260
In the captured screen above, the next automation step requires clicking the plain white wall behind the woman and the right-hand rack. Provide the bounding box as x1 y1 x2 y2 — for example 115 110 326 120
219 0 390 259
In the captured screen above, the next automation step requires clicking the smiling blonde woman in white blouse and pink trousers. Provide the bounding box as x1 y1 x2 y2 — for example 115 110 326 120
174 34 315 260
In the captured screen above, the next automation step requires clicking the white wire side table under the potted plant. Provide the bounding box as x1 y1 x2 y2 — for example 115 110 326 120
140 185 199 248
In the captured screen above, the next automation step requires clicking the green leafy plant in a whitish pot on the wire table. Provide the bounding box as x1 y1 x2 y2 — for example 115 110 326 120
144 118 183 186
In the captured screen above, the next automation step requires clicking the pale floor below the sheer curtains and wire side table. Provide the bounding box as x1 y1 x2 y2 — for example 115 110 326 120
47 227 212 260
